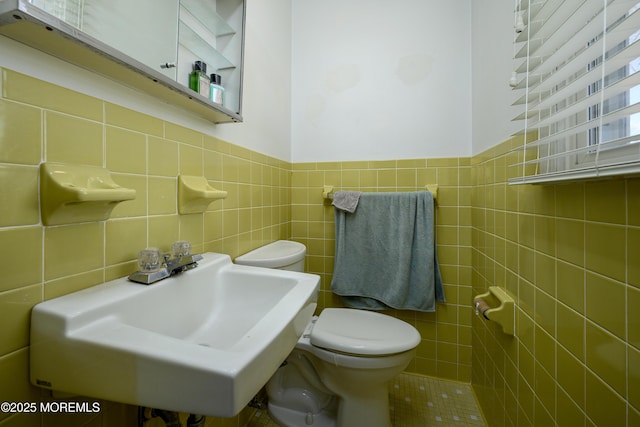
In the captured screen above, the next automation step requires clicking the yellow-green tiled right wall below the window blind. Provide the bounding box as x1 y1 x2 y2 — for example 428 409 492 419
471 138 640 427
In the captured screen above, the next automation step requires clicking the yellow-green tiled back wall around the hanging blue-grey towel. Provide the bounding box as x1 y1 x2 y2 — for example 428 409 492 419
291 158 472 382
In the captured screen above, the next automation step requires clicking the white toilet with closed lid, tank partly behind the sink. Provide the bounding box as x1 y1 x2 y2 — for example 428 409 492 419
235 240 420 427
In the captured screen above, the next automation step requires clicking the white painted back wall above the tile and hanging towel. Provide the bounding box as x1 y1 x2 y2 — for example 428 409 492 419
292 0 472 162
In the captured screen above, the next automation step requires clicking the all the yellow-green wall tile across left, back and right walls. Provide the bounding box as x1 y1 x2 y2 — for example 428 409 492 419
0 61 640 427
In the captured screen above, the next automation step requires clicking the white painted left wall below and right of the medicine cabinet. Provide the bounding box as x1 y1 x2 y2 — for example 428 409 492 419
0 0 291 160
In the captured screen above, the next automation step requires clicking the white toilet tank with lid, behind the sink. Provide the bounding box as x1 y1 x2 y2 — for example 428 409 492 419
235 240 307 272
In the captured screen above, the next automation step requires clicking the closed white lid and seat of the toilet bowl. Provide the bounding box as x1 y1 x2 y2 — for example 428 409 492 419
311 308 421 356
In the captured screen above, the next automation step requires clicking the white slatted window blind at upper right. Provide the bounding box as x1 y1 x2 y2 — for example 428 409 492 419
509 0 640 184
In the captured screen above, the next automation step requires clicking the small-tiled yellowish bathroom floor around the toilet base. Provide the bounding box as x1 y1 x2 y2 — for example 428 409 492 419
247 374 485 427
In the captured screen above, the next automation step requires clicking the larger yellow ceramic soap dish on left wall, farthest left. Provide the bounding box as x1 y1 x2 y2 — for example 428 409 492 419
40 163 136 225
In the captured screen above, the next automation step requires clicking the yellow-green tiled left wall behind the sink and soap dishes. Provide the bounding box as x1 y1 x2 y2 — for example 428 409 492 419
0 69 291 427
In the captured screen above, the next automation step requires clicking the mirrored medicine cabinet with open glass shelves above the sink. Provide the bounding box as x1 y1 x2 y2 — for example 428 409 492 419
0 0 245 123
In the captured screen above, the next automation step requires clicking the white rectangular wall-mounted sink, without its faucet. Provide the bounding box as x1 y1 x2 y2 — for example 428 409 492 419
30 253 320 417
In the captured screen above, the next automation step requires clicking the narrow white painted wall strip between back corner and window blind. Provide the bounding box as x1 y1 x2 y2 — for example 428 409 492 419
471 0 519 154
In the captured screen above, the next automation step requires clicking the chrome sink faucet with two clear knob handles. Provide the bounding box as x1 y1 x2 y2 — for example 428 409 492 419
129 241 202 285
